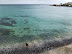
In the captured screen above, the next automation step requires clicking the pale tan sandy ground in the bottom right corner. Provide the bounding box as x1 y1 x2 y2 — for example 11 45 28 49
40 44 72 54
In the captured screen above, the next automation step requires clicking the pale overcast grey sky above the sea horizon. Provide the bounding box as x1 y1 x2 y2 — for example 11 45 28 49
0 0 72 4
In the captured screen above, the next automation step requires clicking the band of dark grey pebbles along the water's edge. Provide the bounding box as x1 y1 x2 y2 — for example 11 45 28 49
0 38 72 54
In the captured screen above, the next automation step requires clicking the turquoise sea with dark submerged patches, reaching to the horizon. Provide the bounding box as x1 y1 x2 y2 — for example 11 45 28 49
0 5 72 44
